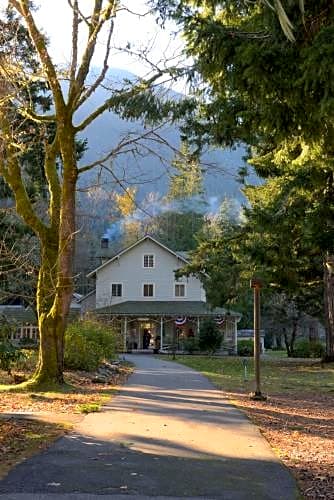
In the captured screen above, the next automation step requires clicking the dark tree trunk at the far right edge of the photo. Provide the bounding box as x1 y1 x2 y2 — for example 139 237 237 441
324 254 334 361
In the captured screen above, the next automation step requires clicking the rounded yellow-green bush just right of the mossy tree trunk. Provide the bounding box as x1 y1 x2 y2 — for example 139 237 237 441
64 320 116 371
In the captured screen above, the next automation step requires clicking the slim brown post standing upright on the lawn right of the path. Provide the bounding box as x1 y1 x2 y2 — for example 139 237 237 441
250 278 266 401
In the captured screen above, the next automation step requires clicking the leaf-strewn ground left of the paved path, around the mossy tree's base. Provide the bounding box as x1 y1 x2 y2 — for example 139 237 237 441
0 366 132 478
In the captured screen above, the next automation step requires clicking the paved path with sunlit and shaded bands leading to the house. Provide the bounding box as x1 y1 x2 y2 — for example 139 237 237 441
0 355 298 500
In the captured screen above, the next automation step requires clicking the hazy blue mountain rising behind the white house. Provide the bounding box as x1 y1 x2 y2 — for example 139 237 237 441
76 70 253 202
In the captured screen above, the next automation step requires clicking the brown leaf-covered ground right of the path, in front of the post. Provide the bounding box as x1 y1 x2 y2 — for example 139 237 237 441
228 392 334 500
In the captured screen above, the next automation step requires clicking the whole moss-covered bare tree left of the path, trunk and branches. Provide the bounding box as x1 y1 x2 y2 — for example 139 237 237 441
0 0 159 388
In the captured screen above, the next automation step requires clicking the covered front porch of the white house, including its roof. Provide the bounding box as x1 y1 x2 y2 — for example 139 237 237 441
94 301 241 354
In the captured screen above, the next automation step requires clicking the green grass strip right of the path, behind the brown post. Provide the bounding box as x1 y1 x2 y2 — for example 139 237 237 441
161 355 334 393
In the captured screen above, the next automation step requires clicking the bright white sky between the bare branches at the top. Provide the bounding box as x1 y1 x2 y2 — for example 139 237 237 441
0 0 182 86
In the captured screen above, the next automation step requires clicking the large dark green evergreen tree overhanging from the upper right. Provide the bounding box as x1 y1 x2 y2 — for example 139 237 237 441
153 0 334 359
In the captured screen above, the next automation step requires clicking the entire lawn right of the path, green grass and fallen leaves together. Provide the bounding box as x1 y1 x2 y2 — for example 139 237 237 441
165 353 334 500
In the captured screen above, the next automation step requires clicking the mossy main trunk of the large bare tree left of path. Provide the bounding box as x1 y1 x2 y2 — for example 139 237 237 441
30 132 77 387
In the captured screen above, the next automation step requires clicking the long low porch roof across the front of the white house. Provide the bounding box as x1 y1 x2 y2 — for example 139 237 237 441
93 300 241 317
